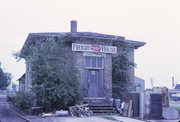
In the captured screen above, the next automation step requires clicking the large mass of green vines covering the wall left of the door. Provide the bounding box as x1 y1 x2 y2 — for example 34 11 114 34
17 37 81 111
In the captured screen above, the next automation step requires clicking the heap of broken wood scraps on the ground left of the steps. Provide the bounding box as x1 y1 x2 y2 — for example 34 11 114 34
69 104 93 117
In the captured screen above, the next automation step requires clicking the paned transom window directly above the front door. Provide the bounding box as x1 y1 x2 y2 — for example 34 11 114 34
85 57 104 69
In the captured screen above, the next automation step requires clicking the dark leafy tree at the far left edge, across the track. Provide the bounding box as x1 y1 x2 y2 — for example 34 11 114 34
0 63 11 89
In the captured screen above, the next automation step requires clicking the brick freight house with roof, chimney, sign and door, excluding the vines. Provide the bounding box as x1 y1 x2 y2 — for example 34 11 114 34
20 21 145 102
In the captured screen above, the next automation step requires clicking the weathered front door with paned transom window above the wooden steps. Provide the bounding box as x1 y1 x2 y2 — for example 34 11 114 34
85 56 104 97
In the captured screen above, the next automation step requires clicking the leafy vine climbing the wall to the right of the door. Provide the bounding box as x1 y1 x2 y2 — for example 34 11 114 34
112 45 135 99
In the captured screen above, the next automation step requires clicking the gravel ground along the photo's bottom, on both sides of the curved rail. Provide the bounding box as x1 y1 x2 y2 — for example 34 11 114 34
0 95 179 122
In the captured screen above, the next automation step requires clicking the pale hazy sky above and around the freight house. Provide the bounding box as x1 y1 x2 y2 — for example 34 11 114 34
0 0 180 88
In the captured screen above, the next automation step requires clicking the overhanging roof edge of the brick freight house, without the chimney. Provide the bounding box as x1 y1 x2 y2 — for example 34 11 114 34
20 32 146 58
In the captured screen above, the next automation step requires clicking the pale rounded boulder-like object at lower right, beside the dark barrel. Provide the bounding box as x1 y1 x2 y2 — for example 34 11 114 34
162 107 179 119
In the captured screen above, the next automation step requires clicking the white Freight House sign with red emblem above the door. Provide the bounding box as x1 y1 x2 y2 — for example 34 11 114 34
72 43 117 54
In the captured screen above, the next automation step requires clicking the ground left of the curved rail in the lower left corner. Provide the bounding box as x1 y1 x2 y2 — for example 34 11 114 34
0 95 25 122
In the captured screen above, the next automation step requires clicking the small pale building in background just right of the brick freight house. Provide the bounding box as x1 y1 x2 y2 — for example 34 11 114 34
134 77 145 93
